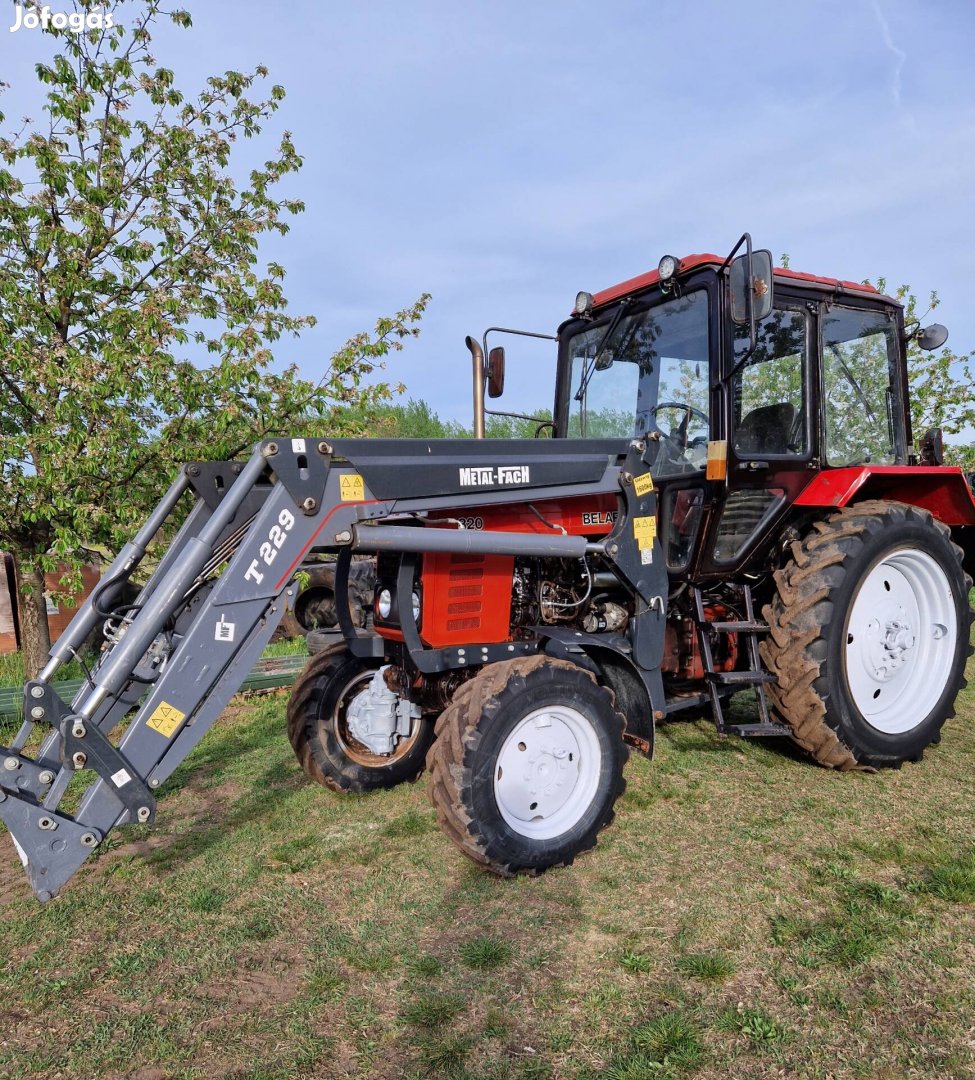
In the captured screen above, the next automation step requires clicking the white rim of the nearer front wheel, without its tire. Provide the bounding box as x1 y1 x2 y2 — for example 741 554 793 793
495 705 602 840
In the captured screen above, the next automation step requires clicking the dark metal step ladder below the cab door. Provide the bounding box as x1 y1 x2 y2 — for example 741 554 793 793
692 585 790 738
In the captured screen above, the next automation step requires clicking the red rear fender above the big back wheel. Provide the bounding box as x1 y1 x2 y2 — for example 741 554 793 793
796 465 975 525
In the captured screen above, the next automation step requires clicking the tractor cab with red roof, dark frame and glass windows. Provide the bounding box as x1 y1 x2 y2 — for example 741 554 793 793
537 234 910 579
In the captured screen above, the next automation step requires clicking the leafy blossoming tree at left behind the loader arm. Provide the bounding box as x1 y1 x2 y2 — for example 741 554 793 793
0 0 428 673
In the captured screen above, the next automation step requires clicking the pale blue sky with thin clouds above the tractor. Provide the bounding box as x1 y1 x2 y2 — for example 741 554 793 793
0 0 975 419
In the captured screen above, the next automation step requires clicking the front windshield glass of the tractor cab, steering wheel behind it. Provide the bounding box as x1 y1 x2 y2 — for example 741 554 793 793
567 289 708 472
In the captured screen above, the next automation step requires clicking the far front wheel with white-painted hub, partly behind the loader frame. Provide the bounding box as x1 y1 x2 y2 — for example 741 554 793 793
287 643 433 792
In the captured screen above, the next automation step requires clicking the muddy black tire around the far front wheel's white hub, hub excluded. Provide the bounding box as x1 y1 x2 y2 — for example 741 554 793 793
287 643 433 793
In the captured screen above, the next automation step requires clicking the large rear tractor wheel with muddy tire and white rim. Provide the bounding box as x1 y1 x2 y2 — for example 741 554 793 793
761 500 972 770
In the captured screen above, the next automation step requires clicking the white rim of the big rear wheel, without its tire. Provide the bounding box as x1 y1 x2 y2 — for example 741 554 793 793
844 549 958 734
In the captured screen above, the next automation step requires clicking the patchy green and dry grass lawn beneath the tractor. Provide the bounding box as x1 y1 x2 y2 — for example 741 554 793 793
0 652 975 1080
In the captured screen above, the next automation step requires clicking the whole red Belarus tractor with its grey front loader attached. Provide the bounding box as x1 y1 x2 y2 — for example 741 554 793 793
0 234 975 901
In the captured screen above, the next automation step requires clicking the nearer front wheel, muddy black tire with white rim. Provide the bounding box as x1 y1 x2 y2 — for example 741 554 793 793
429 657 628 877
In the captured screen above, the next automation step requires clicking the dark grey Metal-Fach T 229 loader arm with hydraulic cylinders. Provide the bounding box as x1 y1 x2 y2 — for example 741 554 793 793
0 438 666 901
